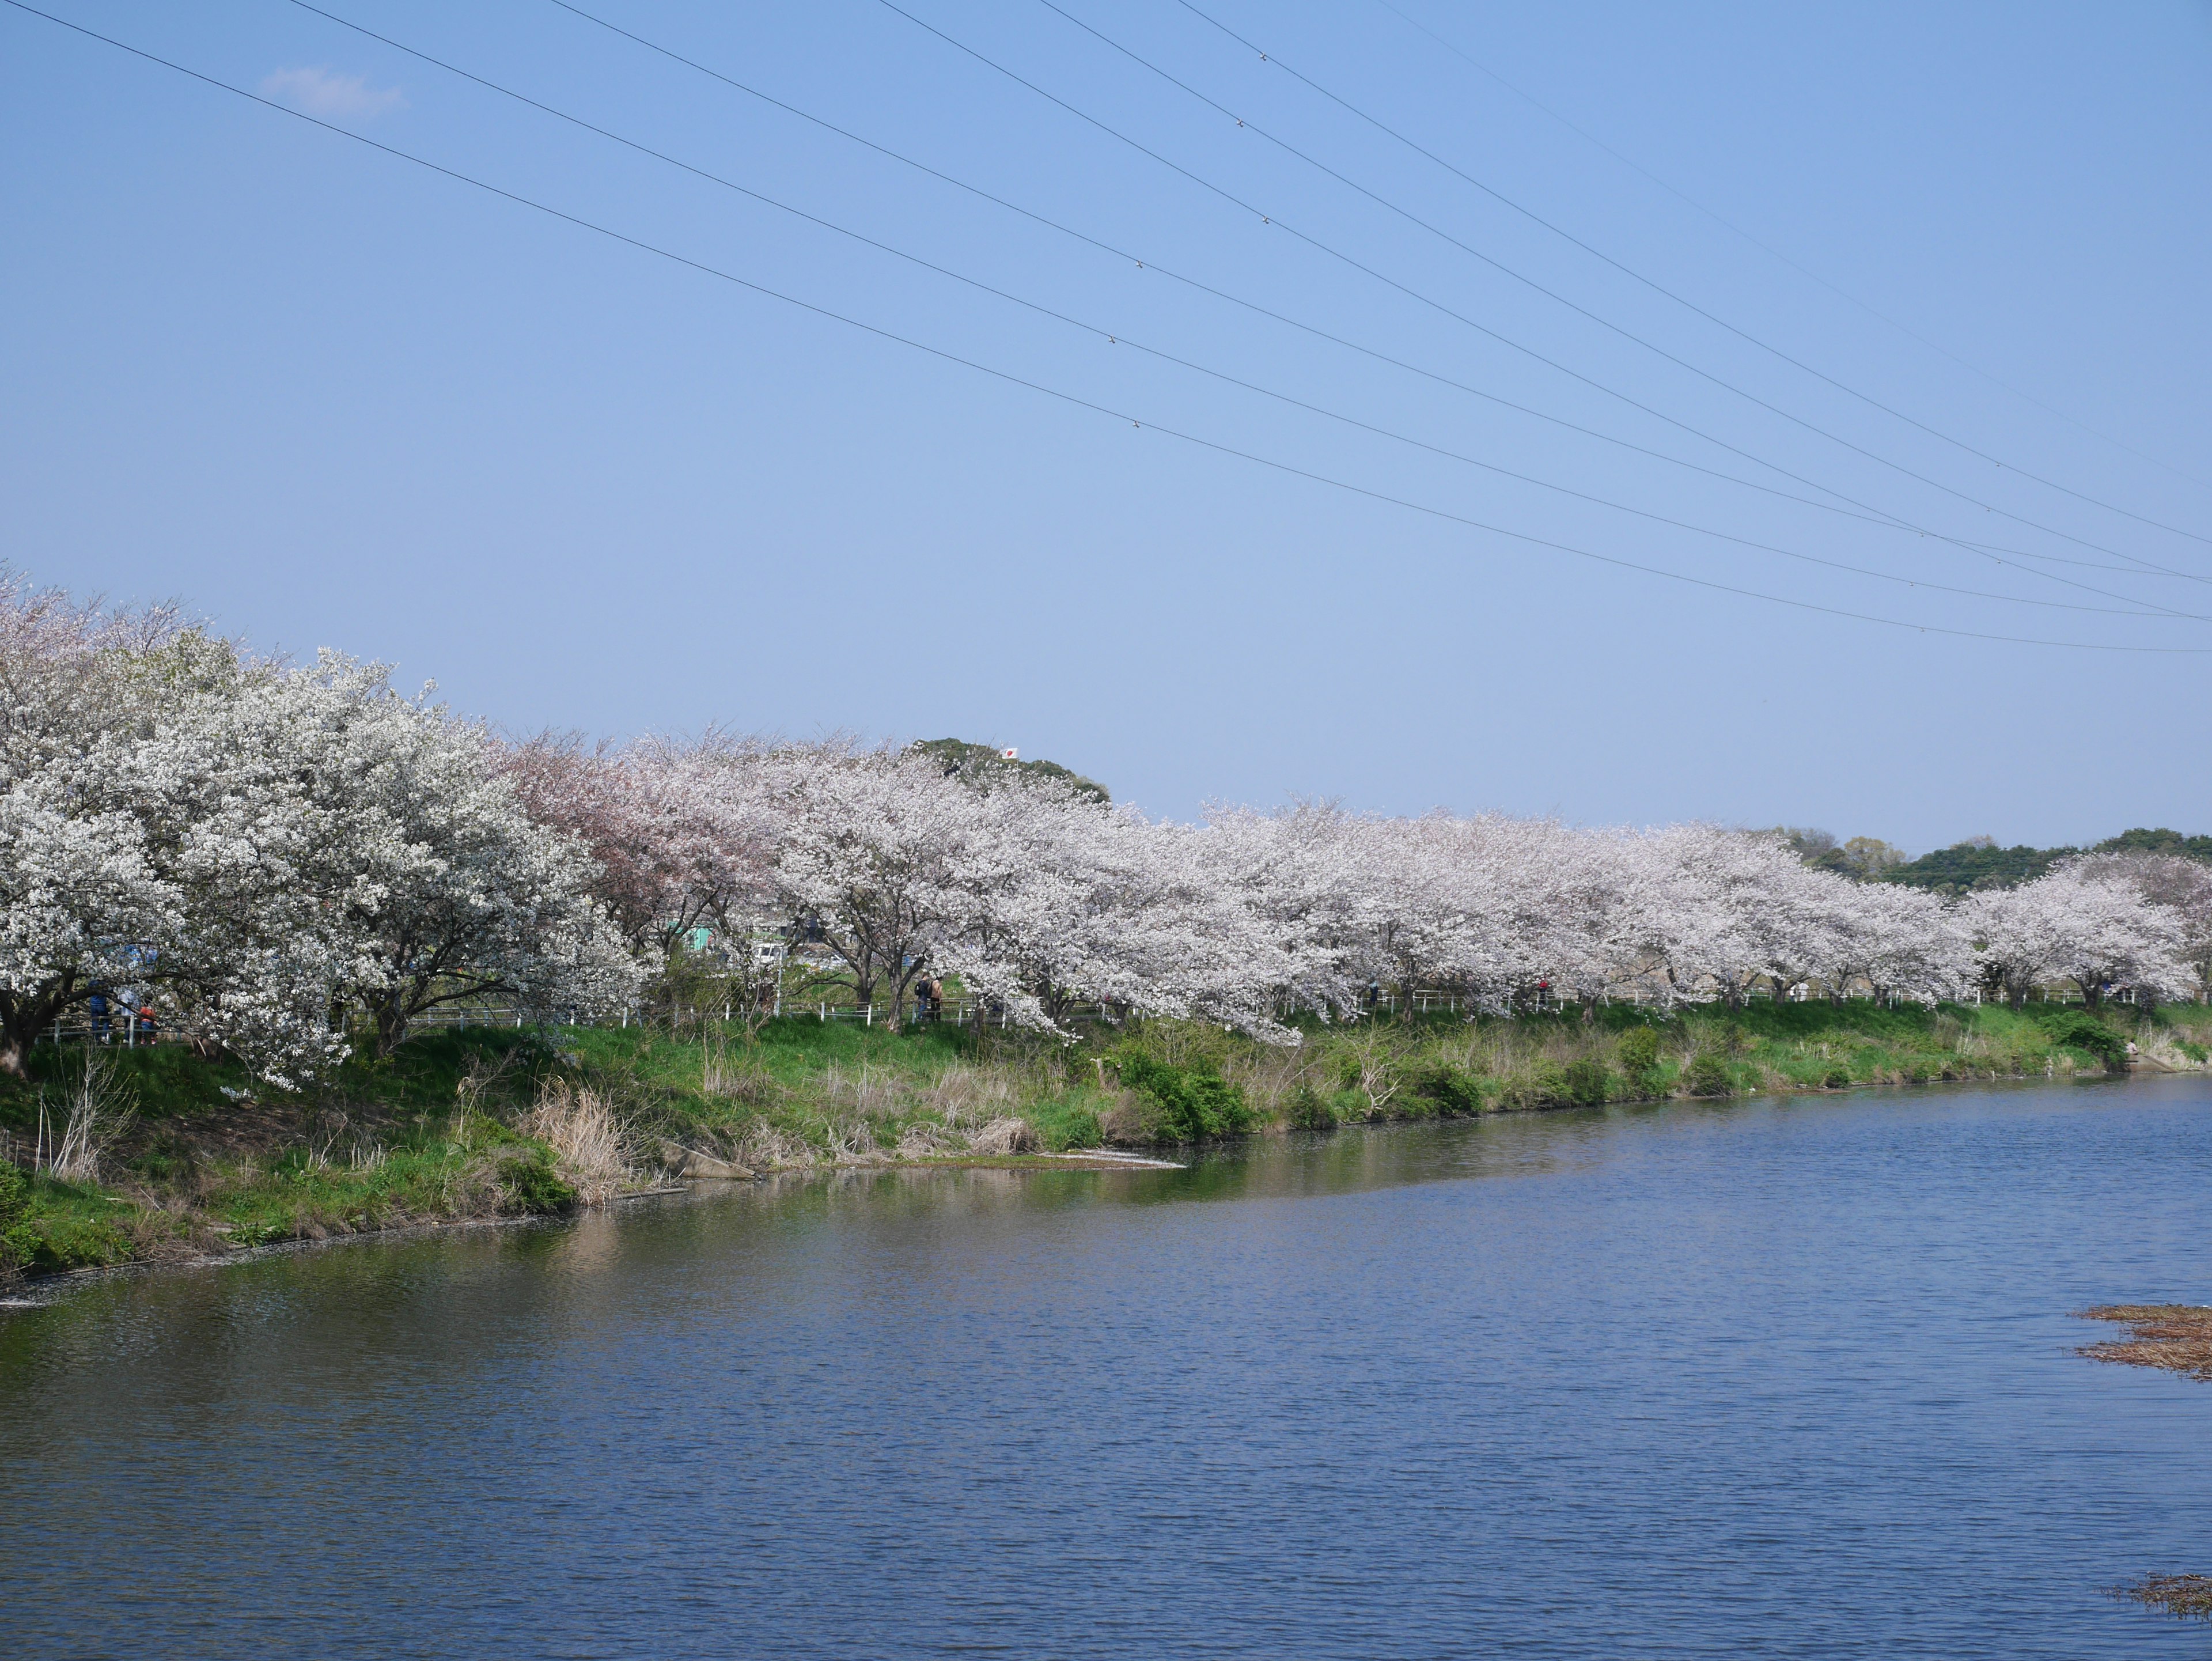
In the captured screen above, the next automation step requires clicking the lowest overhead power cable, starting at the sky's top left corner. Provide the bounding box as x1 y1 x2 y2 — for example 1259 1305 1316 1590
5 0 2212 657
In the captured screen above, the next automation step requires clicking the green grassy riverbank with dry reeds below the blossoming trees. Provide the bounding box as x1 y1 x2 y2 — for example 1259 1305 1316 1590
0 1004 2212 1274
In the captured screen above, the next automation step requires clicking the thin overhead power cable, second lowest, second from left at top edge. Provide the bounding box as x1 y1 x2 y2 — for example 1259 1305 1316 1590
272 0 2212 624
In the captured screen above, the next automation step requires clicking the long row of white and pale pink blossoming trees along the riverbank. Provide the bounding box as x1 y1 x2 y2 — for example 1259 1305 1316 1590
0 577 2212 1084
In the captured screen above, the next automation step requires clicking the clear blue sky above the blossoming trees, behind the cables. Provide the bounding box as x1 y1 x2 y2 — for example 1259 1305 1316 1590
0 0 2212 849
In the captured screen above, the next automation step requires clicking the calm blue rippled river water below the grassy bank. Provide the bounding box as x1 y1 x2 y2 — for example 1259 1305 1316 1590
0 1079 2212 1661
